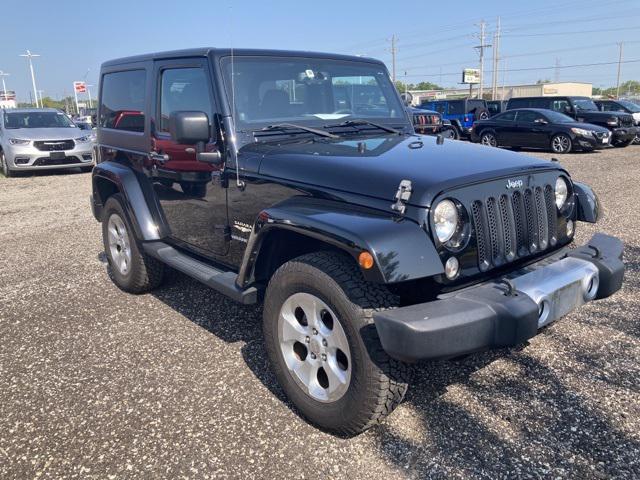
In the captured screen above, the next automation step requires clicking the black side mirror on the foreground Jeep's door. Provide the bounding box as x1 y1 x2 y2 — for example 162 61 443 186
169 111 222 165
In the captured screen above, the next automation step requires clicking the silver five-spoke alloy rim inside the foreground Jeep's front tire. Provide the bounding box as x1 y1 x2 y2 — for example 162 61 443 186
278 293 352 402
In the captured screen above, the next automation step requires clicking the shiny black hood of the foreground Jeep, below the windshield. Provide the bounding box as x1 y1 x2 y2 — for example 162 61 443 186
250 135 559 206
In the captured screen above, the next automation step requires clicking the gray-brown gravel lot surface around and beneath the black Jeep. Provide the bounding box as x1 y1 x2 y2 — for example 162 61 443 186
0 146 640 479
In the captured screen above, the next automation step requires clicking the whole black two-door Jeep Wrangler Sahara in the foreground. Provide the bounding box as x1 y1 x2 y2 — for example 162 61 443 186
91 49 624 434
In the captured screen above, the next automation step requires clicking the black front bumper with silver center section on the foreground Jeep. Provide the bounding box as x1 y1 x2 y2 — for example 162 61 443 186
373 234 624 362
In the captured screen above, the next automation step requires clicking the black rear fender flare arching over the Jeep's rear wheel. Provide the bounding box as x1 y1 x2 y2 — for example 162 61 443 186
91 161 170 242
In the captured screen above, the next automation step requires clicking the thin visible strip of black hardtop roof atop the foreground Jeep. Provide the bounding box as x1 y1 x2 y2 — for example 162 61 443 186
102 47 384 68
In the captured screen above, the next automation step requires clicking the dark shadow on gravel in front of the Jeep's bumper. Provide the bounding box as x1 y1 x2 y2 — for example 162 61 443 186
373 351 640 478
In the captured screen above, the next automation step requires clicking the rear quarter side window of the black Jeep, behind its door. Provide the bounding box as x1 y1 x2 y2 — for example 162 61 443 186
100 70 146 132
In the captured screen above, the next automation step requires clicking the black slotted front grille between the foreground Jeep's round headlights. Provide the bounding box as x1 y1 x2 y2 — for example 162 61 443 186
471 185 558 271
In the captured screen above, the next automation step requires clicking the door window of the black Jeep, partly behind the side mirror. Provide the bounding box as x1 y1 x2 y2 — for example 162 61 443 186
158 68 213 132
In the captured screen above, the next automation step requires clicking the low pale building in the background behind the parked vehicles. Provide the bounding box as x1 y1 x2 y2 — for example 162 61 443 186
409 82 593 105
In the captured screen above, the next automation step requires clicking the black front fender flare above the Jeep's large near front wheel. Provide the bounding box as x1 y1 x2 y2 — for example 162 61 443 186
238 197 444 287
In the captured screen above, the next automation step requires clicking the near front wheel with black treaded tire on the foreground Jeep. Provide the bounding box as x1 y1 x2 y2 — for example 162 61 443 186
263 252 410 435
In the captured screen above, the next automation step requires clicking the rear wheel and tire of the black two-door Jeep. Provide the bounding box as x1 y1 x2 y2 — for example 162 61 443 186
102 193 164 293
